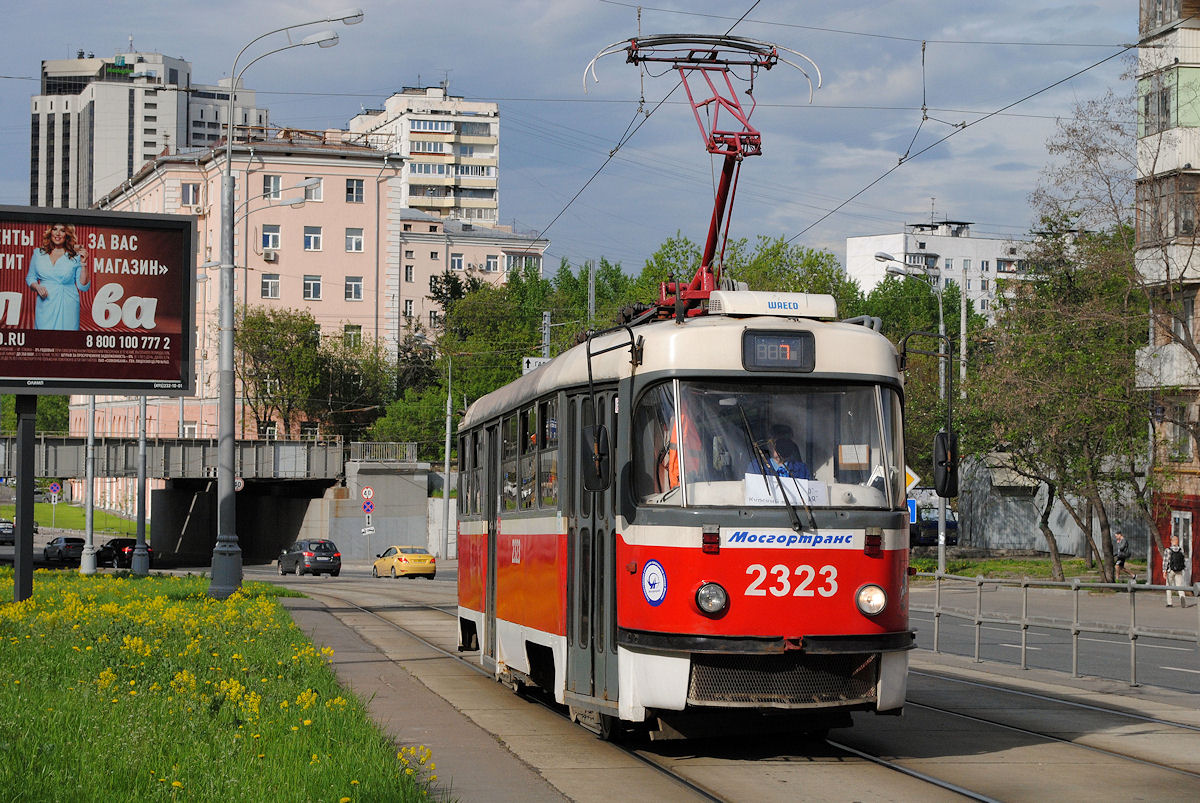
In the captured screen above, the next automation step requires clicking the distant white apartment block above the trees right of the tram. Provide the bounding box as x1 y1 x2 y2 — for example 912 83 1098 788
846 220 1022 322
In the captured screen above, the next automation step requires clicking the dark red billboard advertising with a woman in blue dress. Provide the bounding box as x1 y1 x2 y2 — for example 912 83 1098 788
0 206 196 396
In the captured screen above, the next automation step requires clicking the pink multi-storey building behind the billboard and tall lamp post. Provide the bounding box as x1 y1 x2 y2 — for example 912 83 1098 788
82 131 548 439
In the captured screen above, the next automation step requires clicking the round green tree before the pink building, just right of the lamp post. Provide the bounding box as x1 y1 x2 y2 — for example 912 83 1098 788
234 307 322 435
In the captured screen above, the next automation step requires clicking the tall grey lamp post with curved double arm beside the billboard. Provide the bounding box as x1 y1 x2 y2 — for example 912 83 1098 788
209 8 362 599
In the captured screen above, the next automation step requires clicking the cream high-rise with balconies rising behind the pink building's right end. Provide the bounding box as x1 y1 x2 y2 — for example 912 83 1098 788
349 86 500 226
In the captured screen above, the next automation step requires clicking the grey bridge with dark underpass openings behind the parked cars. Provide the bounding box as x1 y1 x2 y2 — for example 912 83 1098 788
0 437 428 565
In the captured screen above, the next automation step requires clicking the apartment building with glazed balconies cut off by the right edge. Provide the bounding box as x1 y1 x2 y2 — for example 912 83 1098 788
1135 0 1200 583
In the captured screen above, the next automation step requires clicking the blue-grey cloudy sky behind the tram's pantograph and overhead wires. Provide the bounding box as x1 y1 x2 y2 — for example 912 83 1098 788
0 0 1138 272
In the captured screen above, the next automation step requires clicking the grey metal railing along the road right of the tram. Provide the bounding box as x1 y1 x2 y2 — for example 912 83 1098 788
911 571 1200 687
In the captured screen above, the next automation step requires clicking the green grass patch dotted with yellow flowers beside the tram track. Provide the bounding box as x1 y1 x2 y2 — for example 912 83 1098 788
0 568 437 803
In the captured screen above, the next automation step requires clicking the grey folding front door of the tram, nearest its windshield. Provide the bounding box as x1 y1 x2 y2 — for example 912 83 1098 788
566 389 617 701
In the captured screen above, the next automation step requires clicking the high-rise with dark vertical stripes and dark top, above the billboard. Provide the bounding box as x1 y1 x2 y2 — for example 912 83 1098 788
29 50 268 208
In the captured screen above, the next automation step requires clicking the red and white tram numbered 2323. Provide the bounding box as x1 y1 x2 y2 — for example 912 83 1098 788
458 290 913 735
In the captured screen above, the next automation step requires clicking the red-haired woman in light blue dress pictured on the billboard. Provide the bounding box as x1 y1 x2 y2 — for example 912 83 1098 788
25 223 91 330
